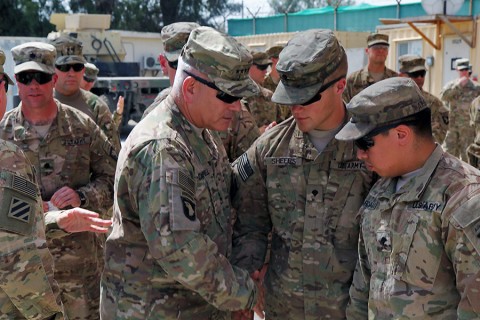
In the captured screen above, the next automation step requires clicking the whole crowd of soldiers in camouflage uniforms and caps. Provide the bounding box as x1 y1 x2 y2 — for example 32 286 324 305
0 16 480 320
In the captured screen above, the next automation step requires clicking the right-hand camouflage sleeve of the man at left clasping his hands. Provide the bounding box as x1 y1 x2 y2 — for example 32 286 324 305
78 121 117 218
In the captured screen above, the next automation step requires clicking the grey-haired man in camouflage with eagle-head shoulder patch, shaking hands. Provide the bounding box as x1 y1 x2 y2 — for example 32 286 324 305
101 27 263 320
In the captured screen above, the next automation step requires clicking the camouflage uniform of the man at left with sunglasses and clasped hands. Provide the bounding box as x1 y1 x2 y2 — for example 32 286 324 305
0 101 116 319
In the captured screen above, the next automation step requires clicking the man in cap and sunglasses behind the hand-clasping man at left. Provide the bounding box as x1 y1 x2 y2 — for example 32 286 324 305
51 36 120 153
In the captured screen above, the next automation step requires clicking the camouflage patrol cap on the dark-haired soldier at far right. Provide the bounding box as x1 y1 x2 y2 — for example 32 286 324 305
335 77 427 140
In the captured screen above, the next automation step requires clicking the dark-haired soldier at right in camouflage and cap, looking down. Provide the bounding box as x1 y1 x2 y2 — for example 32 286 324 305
336 78 480 320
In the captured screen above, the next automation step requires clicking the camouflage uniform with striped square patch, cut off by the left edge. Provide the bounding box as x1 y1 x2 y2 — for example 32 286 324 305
0 140 64 320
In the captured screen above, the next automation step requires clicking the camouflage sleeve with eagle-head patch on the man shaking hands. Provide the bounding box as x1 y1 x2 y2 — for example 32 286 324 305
129 141 257 310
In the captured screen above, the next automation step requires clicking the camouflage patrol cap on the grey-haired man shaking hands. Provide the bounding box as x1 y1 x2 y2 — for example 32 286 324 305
181 27 260 97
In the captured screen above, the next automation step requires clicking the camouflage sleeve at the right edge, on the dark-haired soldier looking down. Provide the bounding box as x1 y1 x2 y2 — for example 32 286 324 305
445 191 480 319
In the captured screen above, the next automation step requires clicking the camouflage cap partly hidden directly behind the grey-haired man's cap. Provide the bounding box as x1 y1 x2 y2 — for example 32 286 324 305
161 22 200 62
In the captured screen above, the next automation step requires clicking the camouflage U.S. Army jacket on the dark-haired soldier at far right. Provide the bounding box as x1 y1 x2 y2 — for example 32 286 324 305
347 146 480 320
